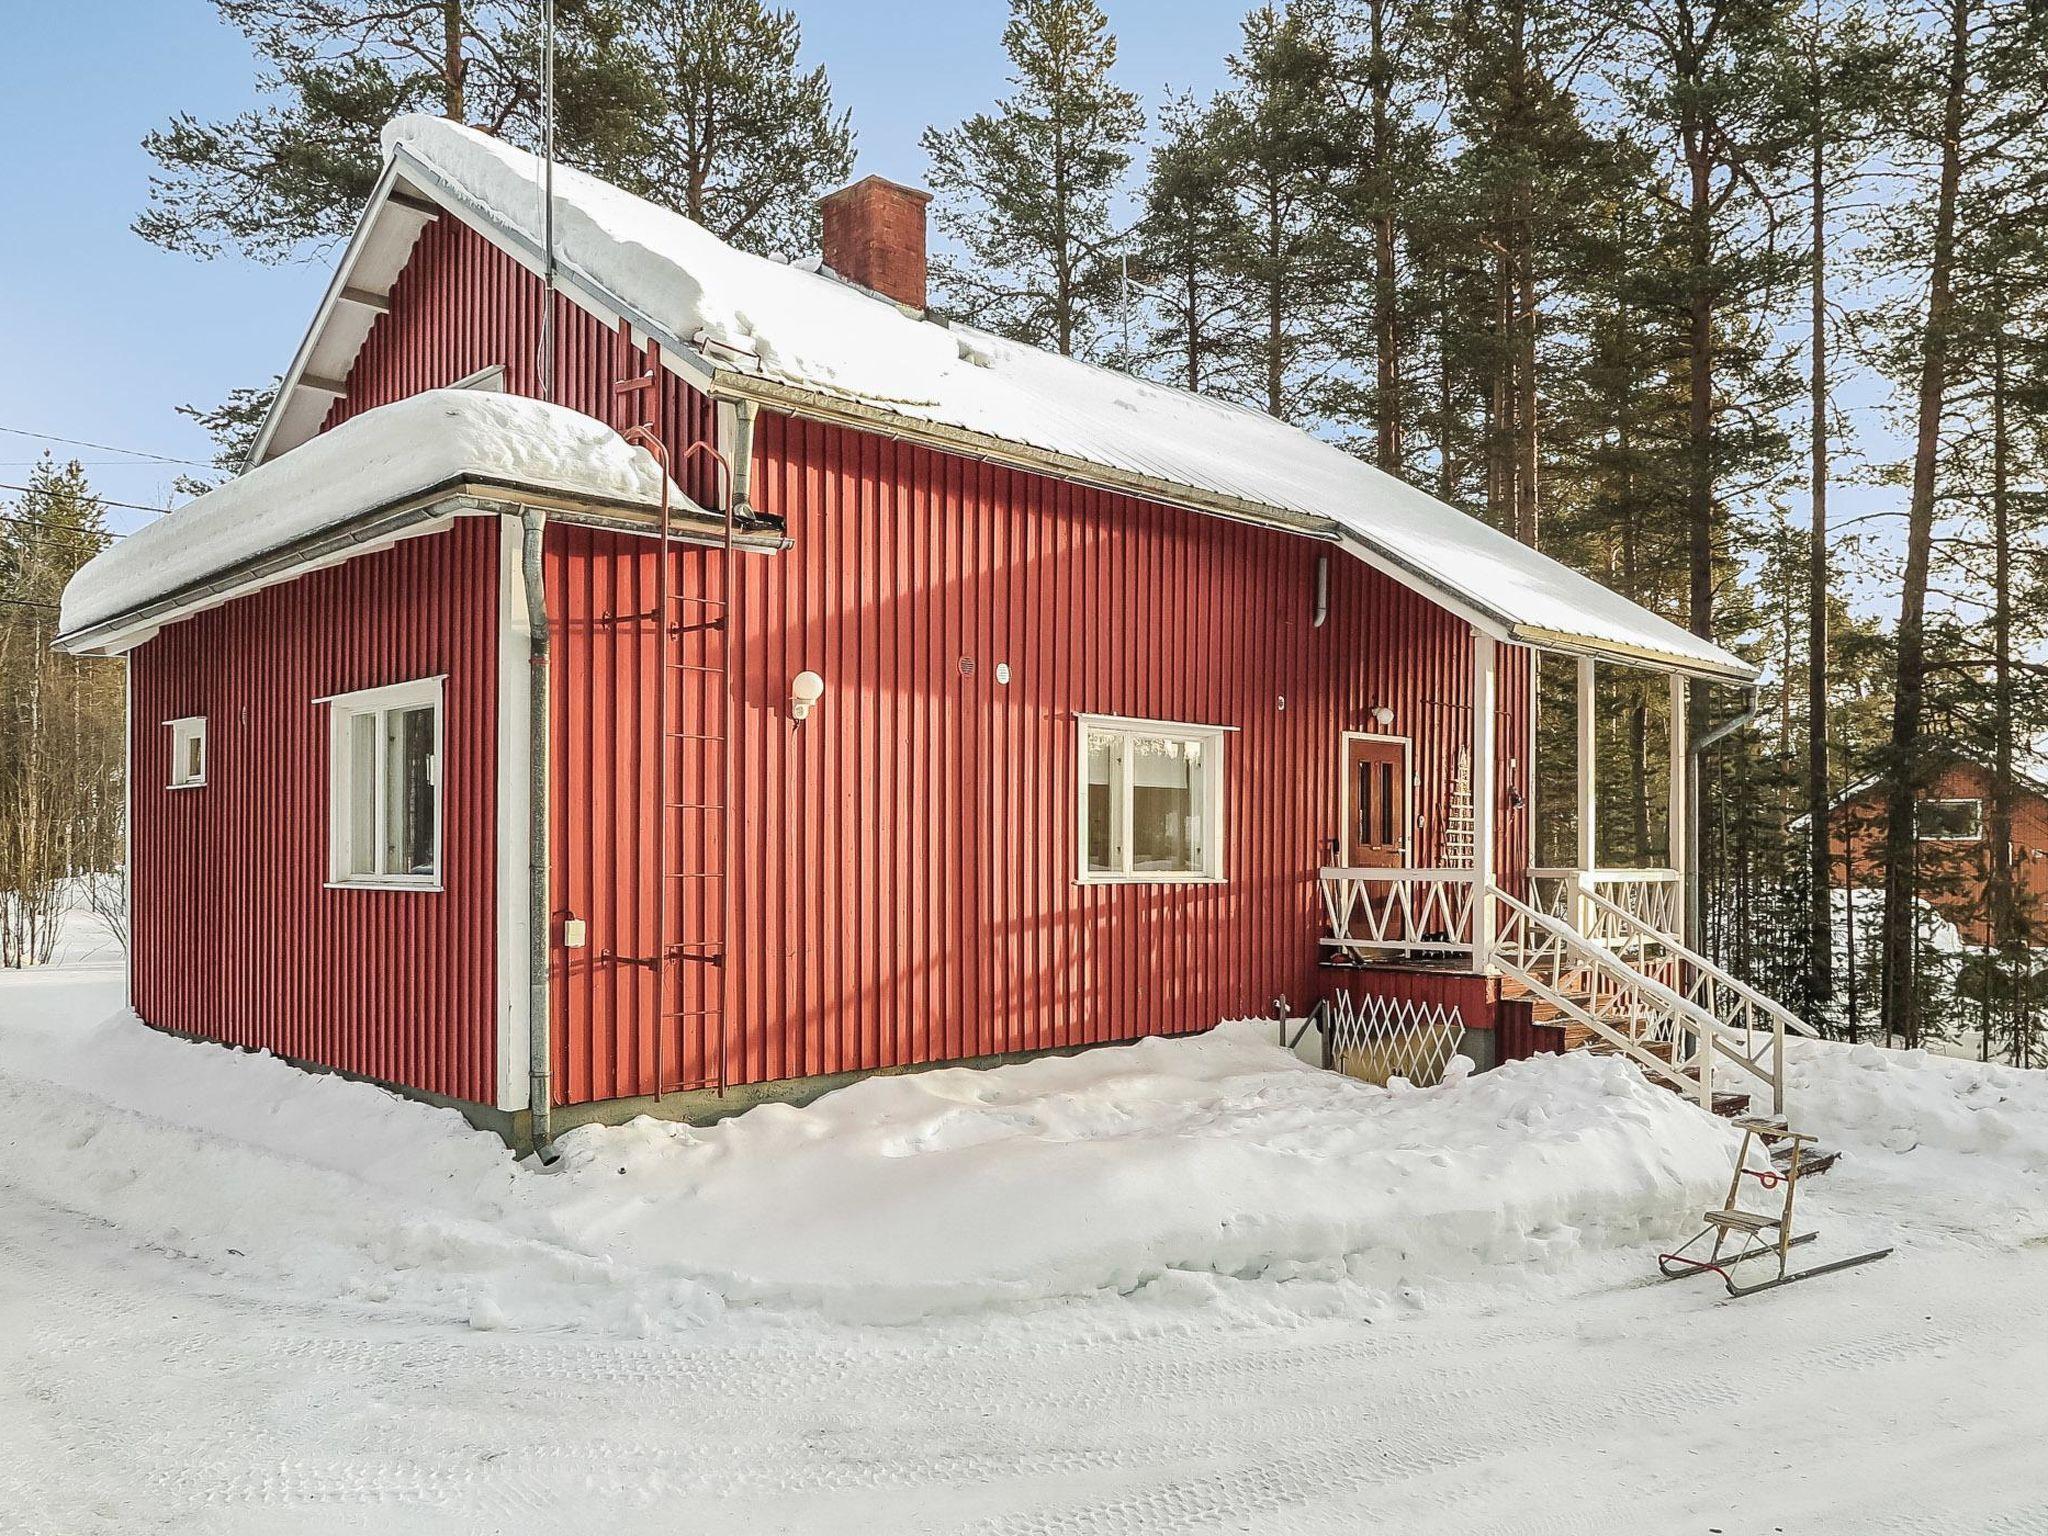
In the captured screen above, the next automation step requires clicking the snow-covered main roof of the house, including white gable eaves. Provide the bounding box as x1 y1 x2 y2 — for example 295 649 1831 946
254 117 1755 682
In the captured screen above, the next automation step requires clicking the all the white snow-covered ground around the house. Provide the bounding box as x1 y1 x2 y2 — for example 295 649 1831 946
0 944 2048 1536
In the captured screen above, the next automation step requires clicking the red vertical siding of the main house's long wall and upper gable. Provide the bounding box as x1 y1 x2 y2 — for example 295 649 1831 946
330 217 1530 1102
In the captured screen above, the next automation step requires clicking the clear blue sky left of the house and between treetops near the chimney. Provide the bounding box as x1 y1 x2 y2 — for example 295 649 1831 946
0 0 1243 526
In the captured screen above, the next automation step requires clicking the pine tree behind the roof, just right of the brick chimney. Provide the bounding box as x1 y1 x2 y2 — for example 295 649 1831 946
922 0 1145 354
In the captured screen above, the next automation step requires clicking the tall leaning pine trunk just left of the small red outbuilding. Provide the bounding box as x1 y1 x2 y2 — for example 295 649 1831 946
1880 0 1970 1047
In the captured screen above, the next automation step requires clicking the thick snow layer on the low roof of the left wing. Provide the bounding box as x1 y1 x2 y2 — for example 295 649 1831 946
59 389 690 643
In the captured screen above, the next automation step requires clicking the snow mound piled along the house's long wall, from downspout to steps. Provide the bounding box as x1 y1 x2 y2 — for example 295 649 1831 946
536 1024 1729 1317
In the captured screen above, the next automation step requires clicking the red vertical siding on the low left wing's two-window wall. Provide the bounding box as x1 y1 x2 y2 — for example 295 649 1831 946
129 518 498 1102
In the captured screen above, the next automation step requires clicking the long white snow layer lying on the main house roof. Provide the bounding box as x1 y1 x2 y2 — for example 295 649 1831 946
383 115 1751 676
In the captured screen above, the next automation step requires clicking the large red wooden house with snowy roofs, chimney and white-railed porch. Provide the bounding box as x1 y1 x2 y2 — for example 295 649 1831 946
61 119 1810 1135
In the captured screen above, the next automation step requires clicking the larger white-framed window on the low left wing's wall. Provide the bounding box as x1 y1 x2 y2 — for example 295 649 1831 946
319 678 442 891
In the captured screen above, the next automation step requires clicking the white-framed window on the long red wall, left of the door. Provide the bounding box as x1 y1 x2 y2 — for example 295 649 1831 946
1075 715 1235 885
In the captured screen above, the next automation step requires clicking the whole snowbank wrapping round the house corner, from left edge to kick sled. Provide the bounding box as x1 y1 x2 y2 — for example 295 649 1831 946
0 973 1729 1331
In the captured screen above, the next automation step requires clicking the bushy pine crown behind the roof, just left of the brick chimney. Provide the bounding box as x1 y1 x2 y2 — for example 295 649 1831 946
594 0 854 252
